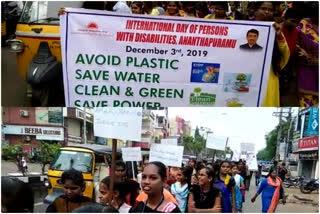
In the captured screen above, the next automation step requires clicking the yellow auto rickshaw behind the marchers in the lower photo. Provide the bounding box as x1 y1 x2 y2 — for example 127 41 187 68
44 144 121 203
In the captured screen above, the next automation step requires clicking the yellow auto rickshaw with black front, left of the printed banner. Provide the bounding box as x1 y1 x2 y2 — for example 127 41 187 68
7 1 83 106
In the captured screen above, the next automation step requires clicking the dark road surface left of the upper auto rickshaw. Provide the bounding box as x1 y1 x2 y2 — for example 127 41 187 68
1 47 30 106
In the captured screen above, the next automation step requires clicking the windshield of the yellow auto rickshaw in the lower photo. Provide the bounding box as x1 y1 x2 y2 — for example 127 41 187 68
50 150 92 173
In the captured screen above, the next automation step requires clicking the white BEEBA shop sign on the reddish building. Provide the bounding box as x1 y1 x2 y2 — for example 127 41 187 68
2 125 64 141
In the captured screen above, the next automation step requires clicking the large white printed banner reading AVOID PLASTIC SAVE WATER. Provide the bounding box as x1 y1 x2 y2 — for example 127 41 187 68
60 8 275 107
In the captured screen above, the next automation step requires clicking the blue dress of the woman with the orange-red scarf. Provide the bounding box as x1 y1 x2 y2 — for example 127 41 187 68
257 178 283 213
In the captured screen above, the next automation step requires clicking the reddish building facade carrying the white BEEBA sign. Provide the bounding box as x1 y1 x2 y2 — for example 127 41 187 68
2 107 65 155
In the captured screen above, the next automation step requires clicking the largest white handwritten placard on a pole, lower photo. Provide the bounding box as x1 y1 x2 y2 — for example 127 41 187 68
93 107 142 141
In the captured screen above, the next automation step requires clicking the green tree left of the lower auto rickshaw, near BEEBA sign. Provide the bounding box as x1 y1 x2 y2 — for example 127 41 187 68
40 141 60 174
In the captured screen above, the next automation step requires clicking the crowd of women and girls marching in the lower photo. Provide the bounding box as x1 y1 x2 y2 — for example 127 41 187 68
1 158 285 213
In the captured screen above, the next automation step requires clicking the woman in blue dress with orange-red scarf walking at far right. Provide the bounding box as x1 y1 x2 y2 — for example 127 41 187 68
251 168 286 213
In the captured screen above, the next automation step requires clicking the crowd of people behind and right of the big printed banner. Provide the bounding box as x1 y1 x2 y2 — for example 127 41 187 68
75 1 319 107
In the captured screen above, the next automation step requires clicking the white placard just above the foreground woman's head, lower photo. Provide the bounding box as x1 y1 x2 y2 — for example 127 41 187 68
149 143 184 167
